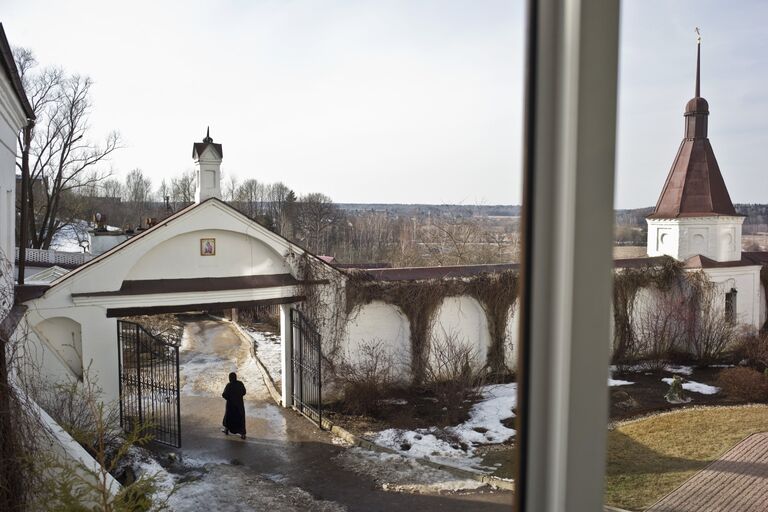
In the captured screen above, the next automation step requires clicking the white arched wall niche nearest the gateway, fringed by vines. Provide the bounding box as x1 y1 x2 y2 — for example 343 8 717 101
340 301 411 382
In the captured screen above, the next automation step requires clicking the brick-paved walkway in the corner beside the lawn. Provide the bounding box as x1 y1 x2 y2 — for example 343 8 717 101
647 433 768 512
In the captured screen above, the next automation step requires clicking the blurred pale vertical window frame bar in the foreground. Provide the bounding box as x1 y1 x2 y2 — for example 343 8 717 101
515 0 619 512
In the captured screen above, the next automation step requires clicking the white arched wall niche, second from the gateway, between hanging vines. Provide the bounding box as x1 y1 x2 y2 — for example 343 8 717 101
429 296 491 372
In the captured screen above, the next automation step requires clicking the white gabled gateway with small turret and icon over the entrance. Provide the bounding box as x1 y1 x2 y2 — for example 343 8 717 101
22 133 335 444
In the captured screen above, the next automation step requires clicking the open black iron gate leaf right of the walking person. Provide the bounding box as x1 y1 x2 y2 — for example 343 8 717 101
291 309 323 425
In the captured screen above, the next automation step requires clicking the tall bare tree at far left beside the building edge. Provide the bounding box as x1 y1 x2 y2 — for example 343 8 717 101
15 49 120 249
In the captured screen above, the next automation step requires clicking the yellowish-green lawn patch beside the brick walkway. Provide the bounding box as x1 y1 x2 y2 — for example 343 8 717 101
605 405 768 510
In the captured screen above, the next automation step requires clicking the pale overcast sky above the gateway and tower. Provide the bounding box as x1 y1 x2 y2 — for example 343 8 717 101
0 0 768 208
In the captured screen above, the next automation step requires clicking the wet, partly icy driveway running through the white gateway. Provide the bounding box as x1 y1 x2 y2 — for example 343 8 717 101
159 319 512 512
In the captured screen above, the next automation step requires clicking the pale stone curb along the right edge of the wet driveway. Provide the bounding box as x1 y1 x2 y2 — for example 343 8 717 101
224 319 515 491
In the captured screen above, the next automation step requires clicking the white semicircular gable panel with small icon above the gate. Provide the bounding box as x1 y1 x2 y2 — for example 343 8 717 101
126 229 289 280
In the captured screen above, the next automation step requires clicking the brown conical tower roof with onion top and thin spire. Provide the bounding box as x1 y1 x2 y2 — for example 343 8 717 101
648 38 738 219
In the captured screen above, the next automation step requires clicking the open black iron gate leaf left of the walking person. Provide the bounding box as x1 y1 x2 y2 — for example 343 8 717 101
117 320 181 448
